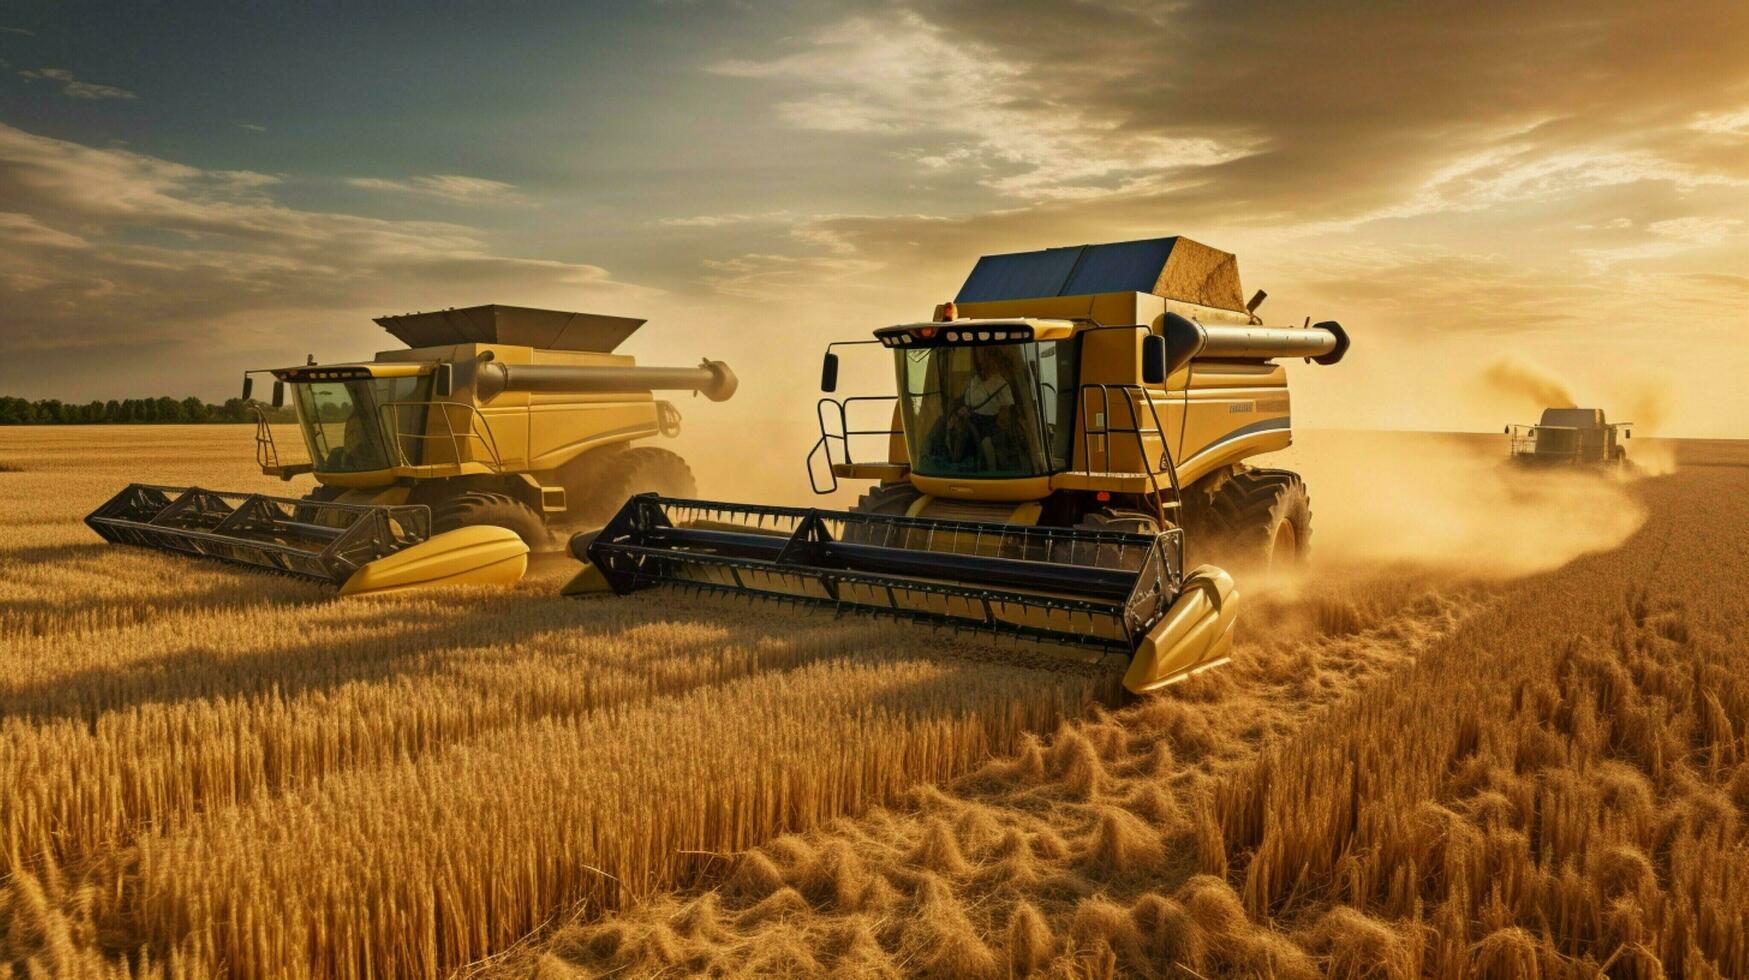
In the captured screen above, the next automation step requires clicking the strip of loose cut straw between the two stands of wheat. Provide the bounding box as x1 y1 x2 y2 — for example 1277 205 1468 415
476 563 1483 977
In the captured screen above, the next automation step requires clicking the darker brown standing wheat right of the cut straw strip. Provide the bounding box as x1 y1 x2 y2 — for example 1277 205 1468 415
1205 469 1749 977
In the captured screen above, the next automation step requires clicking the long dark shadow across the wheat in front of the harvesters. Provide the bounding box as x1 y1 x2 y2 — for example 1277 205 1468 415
0 572 1004 723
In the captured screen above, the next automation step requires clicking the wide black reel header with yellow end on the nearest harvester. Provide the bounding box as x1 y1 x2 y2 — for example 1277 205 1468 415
565 494 1238 693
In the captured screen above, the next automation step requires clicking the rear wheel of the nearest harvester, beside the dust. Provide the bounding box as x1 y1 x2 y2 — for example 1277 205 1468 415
1198 469 1312 569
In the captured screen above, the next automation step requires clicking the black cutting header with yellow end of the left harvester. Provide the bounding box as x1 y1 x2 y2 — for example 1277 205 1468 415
86 483 528 595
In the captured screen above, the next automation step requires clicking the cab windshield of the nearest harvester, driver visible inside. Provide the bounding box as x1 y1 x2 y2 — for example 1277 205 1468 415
897 341 1076 480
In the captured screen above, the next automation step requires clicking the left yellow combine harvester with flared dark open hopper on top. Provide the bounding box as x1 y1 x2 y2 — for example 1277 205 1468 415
86 305 736 595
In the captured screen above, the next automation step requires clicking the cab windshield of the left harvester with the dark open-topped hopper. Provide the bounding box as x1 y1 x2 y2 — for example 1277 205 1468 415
292 376 430 473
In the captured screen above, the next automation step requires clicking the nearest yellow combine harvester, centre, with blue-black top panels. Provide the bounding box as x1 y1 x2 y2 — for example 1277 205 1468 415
565 238 1348 693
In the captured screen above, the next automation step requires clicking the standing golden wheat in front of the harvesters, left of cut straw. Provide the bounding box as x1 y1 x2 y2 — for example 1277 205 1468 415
0 429 1109 977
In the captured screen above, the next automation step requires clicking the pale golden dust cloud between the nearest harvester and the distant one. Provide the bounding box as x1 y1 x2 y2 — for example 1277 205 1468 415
1256 431 1646 578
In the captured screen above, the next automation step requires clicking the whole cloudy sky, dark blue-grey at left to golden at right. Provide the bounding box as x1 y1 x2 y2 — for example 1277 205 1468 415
0 0 1749 438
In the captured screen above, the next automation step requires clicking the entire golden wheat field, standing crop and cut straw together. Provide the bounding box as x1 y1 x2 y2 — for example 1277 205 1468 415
0 427 1749 977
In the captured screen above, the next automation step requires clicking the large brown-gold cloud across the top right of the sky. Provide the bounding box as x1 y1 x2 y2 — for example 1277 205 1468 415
710 0 1749 222
